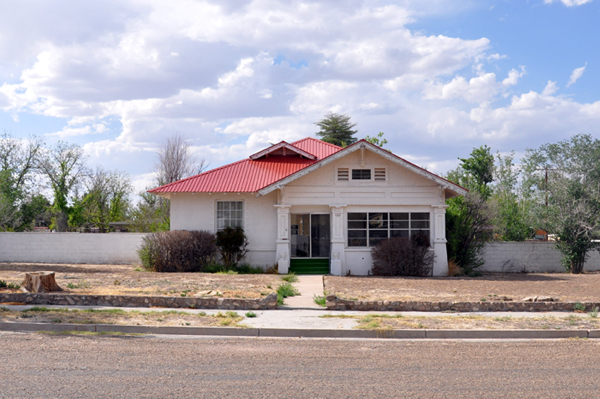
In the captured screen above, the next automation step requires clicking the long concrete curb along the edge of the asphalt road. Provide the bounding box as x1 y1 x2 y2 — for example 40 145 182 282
0 322 600 339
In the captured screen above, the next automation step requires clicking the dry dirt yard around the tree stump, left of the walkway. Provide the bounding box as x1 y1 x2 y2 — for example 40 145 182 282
0 263 281 298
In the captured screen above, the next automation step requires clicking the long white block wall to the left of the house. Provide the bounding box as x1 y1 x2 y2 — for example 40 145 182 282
0 233 146 264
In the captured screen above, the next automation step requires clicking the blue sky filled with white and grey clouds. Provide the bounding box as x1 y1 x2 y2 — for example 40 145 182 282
0 0 600 194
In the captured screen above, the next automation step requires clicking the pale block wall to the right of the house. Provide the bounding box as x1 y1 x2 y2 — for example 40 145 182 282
479 241 600 273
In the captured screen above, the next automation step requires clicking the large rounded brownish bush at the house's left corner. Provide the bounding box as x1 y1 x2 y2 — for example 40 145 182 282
138 230 217 272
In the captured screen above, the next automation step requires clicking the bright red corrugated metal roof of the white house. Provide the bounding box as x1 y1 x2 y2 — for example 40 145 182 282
150 137 342 194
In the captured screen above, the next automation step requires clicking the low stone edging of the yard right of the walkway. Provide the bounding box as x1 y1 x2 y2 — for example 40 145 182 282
326 294 600 312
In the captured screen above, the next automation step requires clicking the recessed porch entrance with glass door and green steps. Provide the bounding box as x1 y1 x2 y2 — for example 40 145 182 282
290 213 331 274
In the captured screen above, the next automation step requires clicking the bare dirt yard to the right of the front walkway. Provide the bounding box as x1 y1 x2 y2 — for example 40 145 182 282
325 272 600 302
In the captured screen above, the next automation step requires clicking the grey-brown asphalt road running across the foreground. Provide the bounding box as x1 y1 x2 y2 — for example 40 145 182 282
0 333 600 398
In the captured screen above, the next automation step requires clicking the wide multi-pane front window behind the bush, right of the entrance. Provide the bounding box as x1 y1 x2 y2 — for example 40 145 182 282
348 212 430 247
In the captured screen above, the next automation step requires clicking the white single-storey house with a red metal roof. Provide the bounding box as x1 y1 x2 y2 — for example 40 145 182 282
150 138 467 276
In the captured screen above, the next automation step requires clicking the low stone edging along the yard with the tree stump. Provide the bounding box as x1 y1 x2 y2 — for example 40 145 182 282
0 292 277 310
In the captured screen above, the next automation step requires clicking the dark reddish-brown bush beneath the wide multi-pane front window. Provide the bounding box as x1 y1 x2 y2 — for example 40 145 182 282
371 237 435 277
